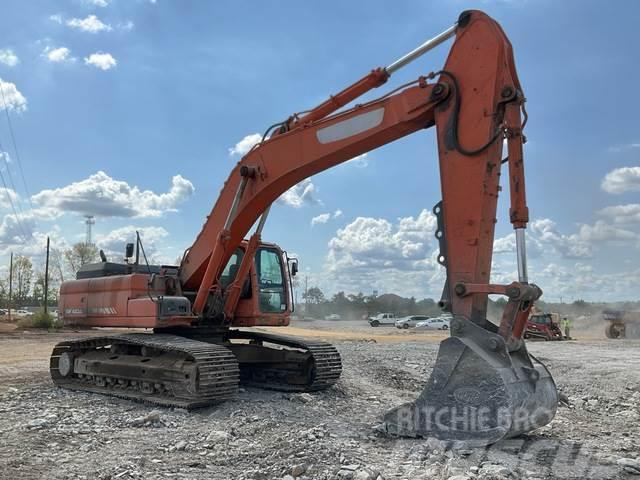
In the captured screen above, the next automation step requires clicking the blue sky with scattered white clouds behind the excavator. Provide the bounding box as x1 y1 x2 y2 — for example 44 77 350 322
0 0 640 300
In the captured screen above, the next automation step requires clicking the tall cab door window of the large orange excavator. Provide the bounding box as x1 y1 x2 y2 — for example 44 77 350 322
256 248 287 313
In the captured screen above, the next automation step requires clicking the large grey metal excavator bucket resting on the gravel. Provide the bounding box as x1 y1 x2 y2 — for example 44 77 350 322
384 317 558 446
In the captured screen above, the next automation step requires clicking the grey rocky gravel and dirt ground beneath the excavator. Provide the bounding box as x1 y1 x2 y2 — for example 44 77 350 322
0 321 640 480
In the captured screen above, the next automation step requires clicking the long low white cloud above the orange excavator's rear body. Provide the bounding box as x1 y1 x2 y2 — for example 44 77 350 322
32 171 195 218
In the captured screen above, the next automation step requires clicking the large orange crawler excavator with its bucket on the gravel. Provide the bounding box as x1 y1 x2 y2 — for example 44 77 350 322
50 10 558 445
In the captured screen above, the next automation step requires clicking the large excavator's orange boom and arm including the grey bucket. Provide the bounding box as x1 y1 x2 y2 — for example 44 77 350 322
180 11 557 443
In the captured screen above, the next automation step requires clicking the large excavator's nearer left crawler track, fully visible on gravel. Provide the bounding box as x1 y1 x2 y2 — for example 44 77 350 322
50 334 239 409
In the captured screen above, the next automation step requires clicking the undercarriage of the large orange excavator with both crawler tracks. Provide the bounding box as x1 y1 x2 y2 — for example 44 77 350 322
50 329 342 409
